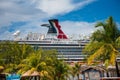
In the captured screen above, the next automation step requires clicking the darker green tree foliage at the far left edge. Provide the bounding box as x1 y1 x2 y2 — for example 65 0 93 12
0 41 33 73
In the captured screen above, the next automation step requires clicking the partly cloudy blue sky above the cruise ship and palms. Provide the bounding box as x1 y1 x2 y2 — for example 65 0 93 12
0 0 120 40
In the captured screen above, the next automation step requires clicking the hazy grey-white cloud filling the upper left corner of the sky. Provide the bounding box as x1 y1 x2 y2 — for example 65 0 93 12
0 0 47 27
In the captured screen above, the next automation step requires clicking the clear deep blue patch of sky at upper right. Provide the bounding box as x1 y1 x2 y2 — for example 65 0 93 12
59 0 120 22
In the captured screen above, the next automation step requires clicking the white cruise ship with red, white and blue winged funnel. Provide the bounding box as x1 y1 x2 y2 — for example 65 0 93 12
16 19 89 62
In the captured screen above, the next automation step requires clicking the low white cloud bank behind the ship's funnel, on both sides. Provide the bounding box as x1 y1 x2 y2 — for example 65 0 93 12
0 21 95 39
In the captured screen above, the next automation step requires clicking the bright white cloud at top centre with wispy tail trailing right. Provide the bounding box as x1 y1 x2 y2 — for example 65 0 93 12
37 0 94 15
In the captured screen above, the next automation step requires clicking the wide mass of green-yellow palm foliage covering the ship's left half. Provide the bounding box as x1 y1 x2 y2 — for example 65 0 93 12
0 42 69 80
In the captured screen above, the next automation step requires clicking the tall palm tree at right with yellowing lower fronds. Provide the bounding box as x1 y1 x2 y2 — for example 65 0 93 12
84 17 120 77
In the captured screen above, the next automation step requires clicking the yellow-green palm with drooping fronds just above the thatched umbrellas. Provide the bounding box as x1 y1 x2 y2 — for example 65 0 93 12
18 50 48 78
